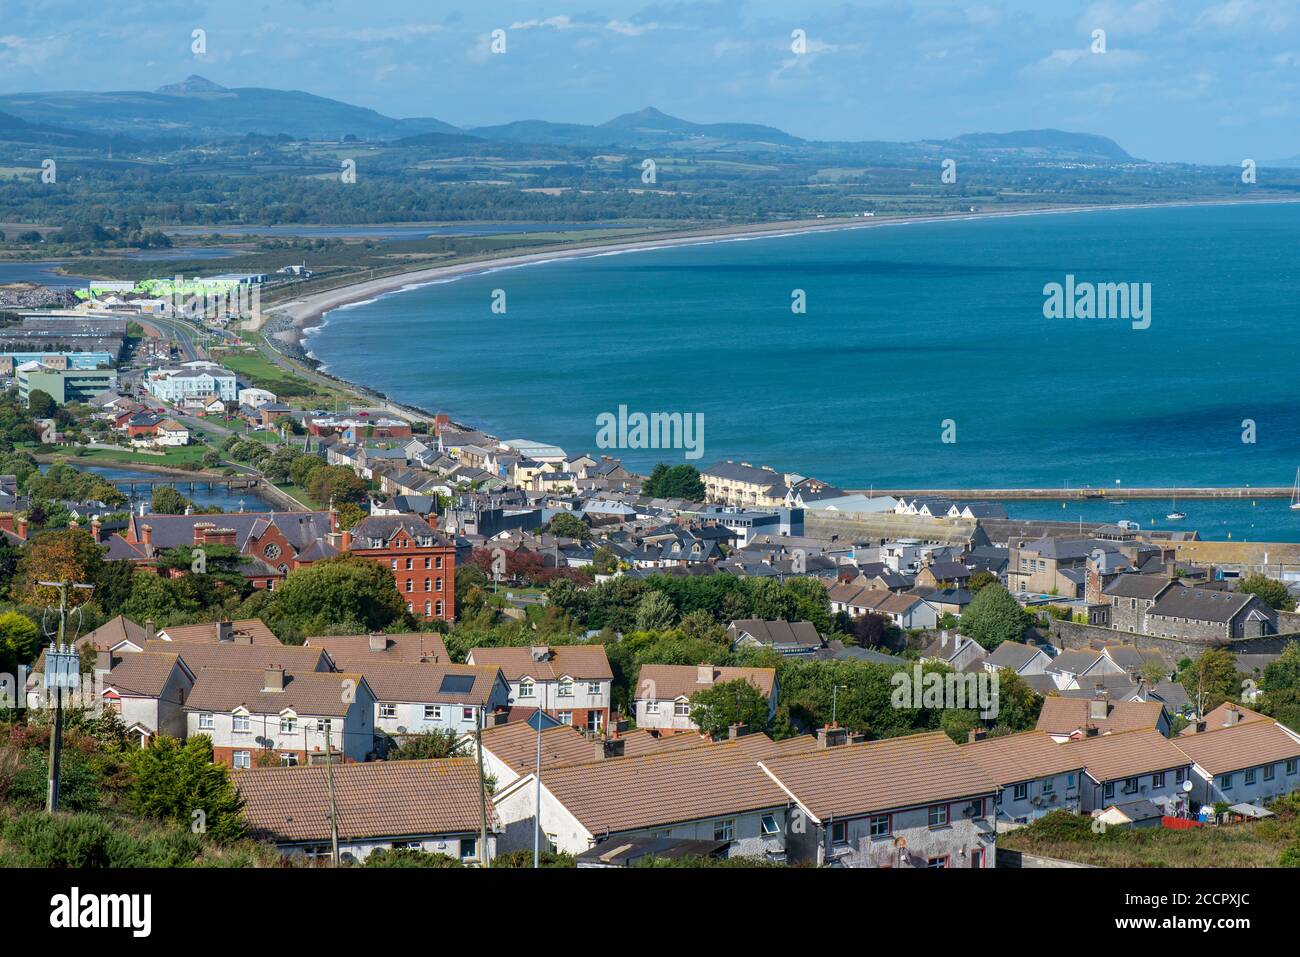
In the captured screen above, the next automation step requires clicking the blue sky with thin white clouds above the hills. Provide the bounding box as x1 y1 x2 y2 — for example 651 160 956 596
0 0 1300 165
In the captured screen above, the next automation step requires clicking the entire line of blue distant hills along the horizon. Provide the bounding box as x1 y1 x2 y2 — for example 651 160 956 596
0 75 1134 163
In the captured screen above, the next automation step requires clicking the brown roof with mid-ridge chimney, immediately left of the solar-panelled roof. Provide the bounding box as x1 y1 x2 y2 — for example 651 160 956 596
185 668 373 718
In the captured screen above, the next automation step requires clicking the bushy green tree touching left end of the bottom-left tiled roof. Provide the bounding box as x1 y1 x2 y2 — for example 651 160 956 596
127 735 246 841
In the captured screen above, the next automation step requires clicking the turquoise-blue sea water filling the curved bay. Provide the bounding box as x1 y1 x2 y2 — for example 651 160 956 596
309 204 1300 540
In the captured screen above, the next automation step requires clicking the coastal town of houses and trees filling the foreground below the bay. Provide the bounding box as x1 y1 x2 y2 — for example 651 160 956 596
0 276 1300 869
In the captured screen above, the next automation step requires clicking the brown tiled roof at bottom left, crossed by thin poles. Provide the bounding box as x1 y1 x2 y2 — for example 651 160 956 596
234 758 497 843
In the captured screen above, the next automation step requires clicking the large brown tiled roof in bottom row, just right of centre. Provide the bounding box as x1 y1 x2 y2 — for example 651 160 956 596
763 732 997 822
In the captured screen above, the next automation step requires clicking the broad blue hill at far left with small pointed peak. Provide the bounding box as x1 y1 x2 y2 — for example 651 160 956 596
0 75 462 139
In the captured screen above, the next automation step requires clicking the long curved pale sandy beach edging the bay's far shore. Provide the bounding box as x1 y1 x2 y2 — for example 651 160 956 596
267 199 1300 346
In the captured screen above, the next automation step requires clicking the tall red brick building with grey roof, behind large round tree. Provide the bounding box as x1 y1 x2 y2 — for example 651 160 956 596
345 515 456 622
